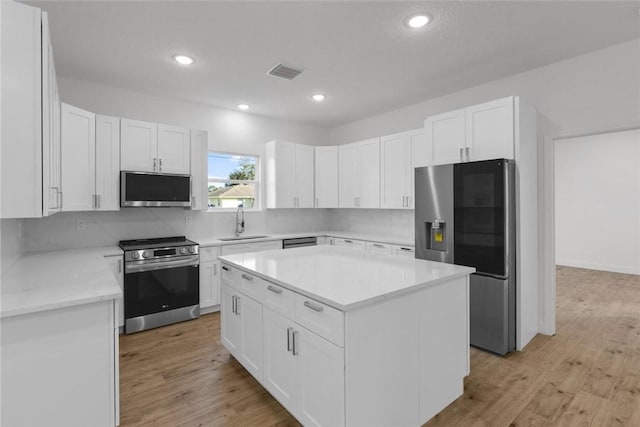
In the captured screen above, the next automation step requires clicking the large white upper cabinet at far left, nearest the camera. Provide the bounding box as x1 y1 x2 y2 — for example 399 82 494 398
0 1 60 218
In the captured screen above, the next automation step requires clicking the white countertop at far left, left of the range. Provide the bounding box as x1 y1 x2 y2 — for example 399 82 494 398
0 246 122 317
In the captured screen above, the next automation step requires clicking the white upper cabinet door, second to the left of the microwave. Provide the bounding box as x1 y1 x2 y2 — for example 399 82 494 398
60 103 96 211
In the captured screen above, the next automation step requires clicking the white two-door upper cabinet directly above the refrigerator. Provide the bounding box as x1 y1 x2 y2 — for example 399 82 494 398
425 97 514 165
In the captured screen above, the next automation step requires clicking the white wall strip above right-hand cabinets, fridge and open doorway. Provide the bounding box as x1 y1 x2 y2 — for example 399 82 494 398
330 39 640 144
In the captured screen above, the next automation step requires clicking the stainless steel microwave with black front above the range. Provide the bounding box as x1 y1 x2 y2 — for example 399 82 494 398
120 171 191 207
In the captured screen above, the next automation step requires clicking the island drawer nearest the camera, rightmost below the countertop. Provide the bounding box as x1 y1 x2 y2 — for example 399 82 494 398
295 294 344 347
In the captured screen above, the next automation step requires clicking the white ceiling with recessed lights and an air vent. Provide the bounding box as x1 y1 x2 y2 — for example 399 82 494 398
27 1 640 128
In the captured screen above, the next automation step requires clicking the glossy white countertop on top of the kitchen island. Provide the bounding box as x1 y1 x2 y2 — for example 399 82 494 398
220 245 475 311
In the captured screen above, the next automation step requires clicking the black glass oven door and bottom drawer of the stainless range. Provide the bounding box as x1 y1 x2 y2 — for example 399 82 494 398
124 257 200 333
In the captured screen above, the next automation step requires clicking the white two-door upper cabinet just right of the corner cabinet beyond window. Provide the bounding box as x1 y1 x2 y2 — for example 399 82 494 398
338 138 380 208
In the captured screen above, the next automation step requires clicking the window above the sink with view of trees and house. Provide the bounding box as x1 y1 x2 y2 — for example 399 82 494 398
207 153 260 210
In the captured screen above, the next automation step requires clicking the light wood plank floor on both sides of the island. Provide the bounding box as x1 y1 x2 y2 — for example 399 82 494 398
120 267 640 427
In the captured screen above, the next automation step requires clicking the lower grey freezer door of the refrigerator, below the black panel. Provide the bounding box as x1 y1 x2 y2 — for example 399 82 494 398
469 274 516 354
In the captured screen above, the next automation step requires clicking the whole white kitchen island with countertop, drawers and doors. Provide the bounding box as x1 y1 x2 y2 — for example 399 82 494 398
221 246 474 426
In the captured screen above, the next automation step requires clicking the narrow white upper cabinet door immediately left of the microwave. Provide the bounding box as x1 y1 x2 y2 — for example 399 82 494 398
96 115 120 211
